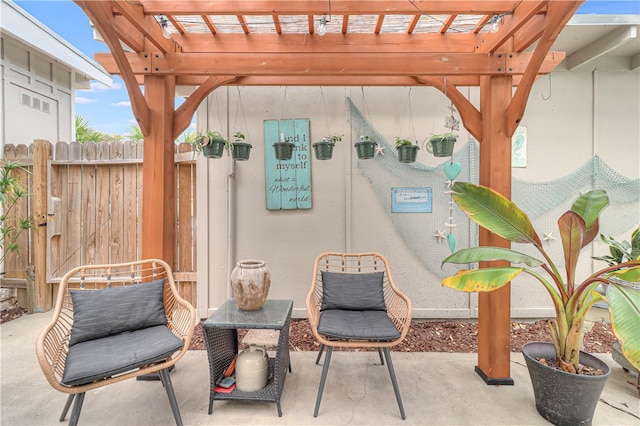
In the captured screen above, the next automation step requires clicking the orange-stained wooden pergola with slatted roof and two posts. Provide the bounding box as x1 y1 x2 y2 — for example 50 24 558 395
74 0 584 384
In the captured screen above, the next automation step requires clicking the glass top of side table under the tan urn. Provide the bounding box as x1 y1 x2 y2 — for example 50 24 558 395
202 299 293 330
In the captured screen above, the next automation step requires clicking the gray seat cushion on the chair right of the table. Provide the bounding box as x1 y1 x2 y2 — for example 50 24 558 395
318 309 400 341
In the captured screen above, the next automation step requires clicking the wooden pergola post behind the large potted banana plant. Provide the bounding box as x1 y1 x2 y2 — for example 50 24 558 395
476 76 513 385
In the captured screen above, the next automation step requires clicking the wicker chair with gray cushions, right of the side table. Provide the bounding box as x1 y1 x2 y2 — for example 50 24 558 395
307 253 411 419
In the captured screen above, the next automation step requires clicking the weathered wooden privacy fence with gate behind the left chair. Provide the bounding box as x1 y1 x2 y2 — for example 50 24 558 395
2 140 197 312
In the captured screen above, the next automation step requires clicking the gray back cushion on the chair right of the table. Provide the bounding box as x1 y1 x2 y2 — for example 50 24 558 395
320 271 386 311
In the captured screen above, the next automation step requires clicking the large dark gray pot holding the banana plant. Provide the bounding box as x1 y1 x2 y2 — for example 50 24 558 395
522 342 611 426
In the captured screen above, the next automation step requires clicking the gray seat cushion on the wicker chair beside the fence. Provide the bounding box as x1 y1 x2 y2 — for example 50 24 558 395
61 325 184 386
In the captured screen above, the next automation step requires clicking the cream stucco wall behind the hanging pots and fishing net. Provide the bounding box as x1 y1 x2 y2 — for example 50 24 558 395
197 70 640 318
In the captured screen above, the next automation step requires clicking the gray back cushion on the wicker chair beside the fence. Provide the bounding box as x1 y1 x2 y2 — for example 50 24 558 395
69 279 167 346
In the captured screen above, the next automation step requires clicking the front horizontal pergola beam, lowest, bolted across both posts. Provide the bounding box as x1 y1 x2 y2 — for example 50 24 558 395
96 53 563 79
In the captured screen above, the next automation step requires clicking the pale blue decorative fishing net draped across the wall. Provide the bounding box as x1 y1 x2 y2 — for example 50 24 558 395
347 98 640 277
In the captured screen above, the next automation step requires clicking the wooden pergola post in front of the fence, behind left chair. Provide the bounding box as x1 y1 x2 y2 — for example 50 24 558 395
142 75 176 267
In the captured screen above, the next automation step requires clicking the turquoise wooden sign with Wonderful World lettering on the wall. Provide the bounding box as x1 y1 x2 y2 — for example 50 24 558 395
264 118 311 210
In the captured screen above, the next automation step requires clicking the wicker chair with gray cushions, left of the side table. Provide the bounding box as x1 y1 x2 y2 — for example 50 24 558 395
36 259 196 425
